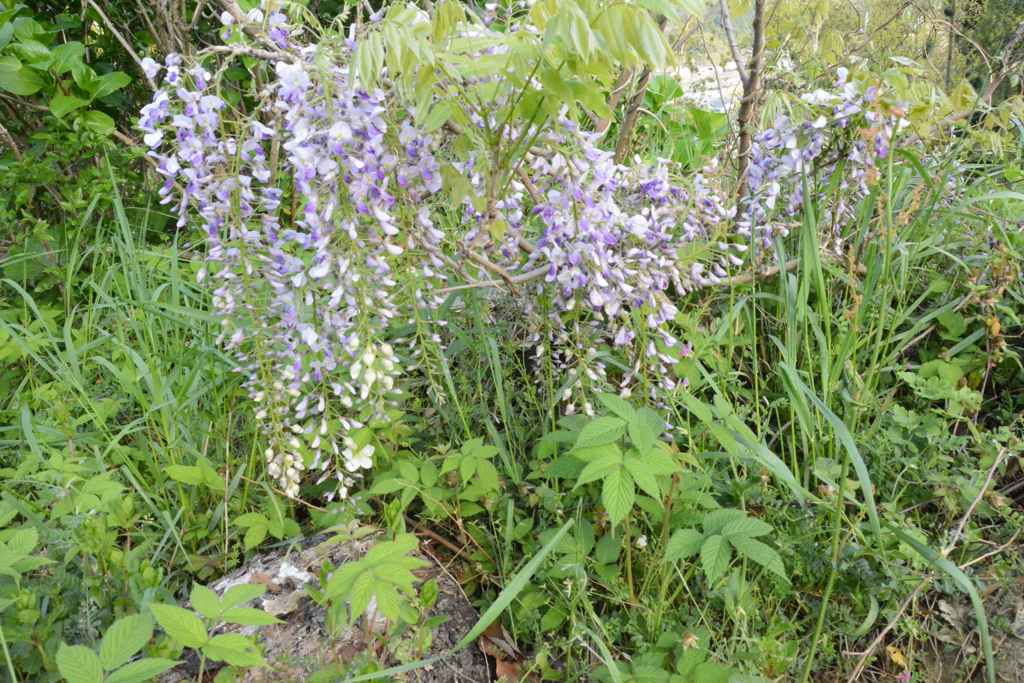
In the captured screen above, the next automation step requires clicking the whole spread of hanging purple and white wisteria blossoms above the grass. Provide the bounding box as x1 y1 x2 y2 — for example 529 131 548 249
138 3 929 505
